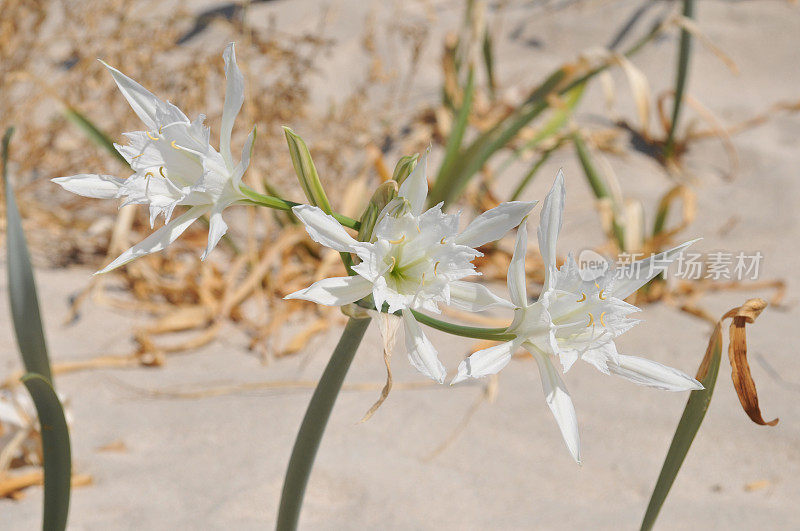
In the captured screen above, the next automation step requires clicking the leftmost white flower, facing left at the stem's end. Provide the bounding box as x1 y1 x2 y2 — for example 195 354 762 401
53 43 255 273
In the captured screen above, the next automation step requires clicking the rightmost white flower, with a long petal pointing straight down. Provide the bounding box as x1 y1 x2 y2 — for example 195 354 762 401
452 172 703 462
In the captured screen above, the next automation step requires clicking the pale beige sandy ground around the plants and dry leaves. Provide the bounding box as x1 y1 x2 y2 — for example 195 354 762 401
0 0 800 530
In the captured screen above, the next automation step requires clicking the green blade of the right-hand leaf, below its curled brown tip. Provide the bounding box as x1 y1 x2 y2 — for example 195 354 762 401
641 324 722 531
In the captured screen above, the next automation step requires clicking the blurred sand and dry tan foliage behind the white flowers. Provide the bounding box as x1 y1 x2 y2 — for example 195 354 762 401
0 0 800 529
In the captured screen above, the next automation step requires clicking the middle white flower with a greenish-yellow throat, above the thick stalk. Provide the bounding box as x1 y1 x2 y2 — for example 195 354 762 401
286 153 535 383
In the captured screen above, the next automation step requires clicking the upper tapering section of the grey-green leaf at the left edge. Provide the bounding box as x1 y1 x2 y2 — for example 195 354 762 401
3 127 52 381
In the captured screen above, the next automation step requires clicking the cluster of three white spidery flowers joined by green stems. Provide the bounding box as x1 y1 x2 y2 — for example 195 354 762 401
54 44 702 462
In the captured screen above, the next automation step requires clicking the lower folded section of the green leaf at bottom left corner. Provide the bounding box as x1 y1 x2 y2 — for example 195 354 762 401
22 373 72 531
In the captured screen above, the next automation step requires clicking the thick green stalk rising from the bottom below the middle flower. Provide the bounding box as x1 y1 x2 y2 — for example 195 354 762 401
276 318 370 531
